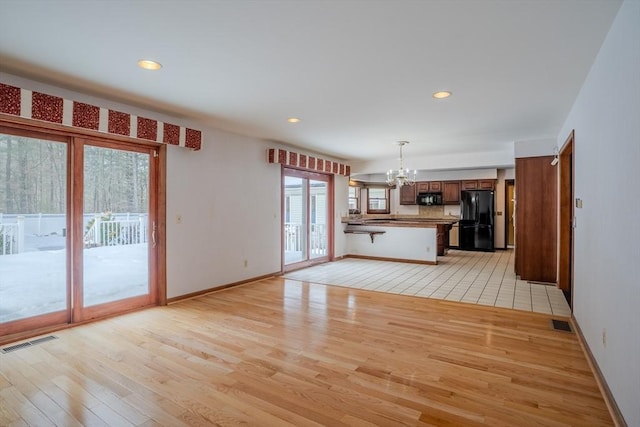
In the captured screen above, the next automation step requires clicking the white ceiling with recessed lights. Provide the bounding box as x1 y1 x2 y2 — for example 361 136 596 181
0 0 620 161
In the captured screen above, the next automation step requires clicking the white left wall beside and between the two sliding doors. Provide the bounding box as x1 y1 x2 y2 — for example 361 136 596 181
167 130 348 298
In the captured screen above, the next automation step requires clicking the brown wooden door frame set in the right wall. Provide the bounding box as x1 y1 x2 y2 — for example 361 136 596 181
558 130 575 308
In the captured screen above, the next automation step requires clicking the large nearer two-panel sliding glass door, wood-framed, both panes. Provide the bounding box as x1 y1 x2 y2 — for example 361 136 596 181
0 127 158 338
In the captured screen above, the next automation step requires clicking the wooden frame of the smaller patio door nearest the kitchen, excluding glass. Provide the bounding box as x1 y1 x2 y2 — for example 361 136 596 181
281 166 334 272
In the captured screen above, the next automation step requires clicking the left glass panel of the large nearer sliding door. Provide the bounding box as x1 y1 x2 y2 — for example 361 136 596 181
0 129 70 334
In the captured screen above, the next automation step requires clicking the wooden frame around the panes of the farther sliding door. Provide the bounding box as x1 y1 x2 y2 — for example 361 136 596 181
280 165 334 272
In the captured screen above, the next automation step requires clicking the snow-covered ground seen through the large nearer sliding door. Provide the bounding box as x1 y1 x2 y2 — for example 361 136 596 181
0 241 149 323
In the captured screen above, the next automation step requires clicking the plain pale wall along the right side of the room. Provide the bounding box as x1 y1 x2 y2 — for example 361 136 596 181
556 0 640 426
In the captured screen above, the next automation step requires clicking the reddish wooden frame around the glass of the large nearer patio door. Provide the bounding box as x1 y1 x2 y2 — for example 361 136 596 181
0 118 167 344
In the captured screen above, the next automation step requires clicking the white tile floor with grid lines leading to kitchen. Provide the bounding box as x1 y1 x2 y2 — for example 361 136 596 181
285 249 571 317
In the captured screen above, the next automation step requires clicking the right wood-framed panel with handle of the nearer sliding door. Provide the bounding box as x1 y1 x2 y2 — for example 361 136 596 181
75 141 157 319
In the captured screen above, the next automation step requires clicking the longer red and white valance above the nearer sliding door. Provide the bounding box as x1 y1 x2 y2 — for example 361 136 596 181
0 83 202 150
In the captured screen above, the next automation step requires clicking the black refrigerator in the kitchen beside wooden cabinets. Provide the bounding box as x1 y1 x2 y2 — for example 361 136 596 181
459 190 494 251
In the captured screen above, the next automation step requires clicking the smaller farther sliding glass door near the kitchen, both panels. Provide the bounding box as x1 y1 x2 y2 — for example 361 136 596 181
282 168 332 271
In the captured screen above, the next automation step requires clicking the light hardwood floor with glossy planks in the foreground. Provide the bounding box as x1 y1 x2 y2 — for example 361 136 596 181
0 278 612 426
